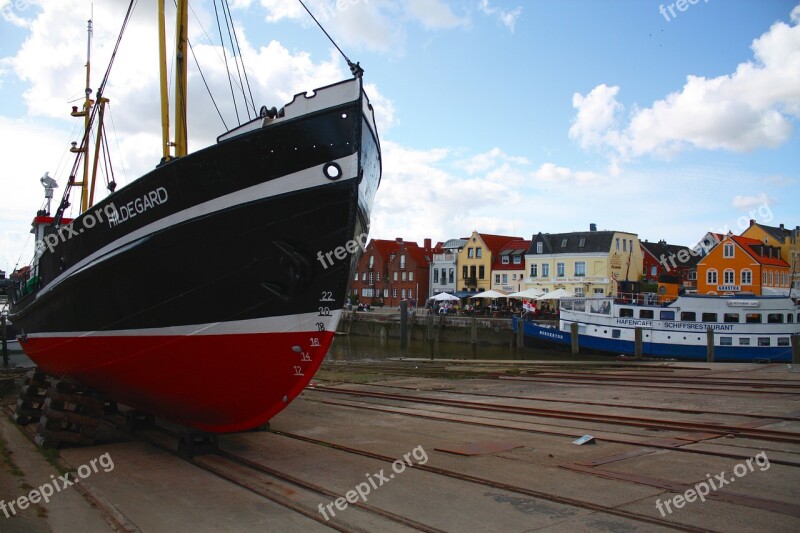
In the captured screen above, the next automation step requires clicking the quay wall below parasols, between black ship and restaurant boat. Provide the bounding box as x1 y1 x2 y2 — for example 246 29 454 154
336 311 515 346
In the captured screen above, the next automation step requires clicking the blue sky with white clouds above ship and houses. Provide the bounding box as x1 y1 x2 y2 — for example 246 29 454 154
0 0 800 271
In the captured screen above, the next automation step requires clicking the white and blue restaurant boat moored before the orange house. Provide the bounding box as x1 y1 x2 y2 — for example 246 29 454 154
515 294 800 362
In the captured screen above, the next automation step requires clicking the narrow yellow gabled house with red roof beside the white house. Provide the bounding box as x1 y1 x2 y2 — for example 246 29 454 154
456 231 519 292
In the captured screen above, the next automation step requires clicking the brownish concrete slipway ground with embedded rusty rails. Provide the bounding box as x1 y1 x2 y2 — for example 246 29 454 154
0 354 800 532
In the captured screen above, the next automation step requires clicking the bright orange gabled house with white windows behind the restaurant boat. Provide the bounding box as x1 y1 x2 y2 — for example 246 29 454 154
697 235 791 295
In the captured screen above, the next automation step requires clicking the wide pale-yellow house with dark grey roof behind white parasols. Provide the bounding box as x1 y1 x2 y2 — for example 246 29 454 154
525 224 643 296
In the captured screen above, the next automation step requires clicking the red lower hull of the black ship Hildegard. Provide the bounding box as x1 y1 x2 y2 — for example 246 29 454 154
22 320 334 433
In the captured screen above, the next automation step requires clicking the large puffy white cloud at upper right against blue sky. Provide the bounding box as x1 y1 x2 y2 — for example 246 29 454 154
569 7 800 166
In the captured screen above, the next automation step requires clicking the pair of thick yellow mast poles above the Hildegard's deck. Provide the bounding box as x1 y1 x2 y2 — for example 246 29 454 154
158 0 189 161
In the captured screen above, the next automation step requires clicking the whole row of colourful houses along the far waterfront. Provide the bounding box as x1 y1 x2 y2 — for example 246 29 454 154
351 220 800 306
